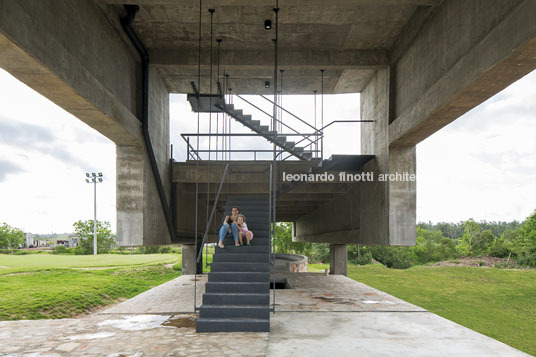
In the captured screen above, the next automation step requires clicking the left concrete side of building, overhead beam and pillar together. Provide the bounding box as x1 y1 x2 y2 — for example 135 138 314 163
0 0 170 245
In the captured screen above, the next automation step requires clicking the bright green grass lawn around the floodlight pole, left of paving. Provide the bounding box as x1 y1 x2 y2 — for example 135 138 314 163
0 254 181 320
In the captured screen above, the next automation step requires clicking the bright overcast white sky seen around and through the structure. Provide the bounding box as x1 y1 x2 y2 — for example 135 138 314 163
0 69 536 233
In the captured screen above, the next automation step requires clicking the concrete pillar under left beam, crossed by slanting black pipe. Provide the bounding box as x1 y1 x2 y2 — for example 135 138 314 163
116 69 171 246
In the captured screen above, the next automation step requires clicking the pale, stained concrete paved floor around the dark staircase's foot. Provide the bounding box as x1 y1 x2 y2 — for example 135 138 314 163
0 273 527 357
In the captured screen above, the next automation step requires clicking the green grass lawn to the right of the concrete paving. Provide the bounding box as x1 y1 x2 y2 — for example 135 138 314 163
309 264 536 355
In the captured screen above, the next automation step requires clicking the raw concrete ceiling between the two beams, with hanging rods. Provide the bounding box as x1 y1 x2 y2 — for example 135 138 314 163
100 0 440 94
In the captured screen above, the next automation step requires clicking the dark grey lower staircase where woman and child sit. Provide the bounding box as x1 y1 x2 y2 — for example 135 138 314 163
196 196 270 332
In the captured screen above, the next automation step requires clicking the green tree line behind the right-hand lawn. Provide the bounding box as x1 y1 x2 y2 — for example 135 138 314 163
276 211 536 269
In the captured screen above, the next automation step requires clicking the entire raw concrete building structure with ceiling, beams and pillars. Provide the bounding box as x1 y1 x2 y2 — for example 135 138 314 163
0 0 536 257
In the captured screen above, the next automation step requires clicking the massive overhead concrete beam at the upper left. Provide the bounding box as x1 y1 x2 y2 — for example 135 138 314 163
0 0 141 146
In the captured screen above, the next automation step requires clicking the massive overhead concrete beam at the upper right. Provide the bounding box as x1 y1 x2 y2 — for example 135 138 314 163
389 0 536 146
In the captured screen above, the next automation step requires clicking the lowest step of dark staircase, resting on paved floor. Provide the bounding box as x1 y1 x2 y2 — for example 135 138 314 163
196 317 270 332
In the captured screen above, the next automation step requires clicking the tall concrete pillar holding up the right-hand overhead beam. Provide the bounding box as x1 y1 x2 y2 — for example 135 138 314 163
359 68 416 245
